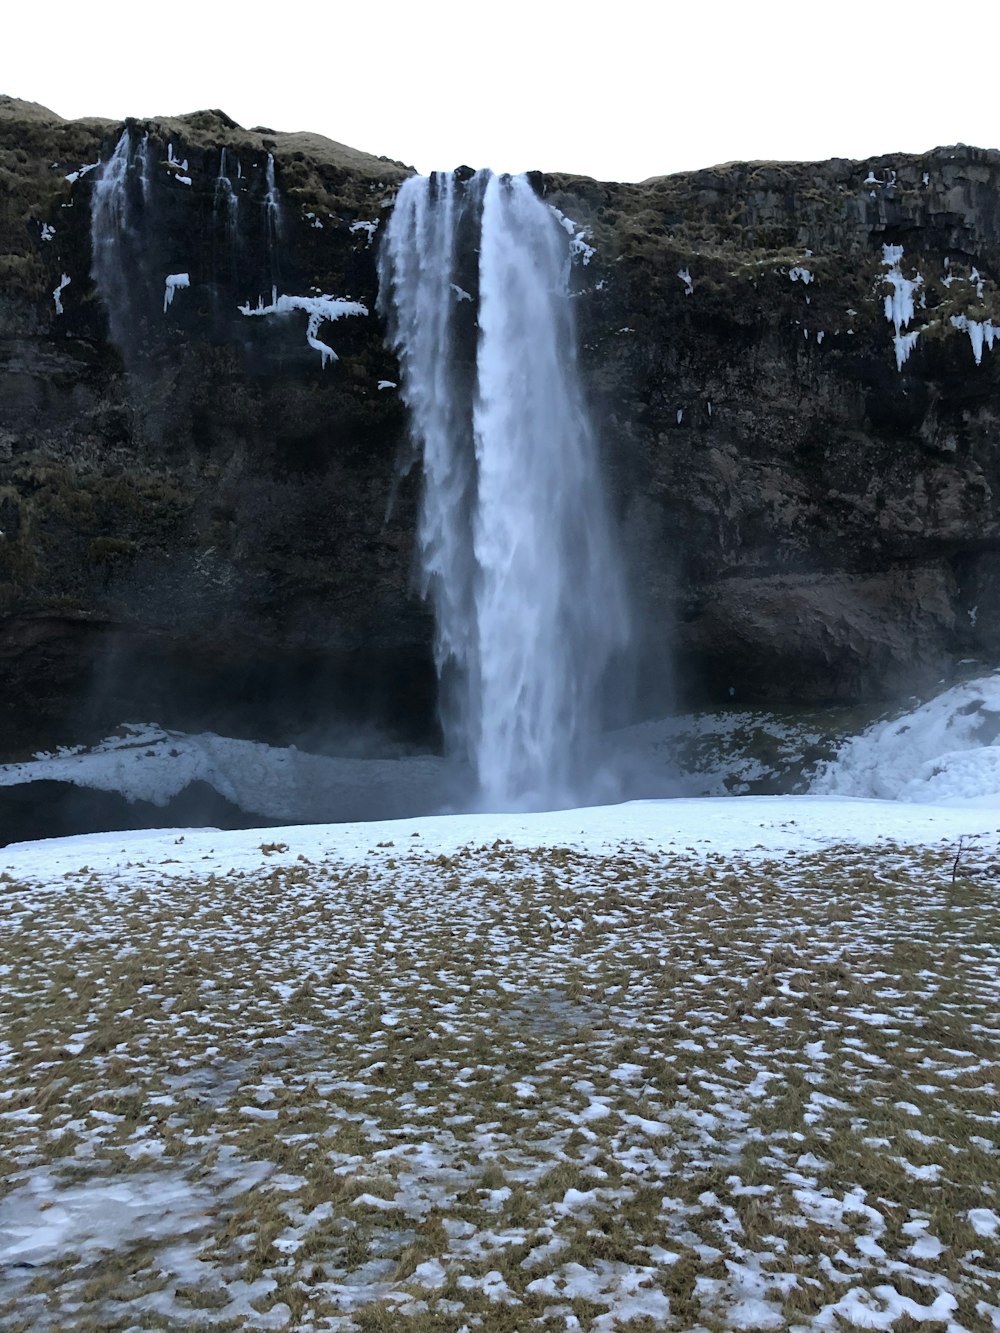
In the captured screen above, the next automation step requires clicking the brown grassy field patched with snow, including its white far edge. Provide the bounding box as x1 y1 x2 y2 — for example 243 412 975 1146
0 797 1000 1333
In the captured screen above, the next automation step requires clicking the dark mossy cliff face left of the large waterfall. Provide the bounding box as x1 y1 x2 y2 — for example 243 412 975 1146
0 103 435 748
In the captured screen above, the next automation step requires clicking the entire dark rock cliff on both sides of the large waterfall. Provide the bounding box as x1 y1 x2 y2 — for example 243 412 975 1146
0 99 1000 754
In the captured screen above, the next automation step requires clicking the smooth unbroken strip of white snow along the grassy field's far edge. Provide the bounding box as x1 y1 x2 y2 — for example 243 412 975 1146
0 796 1000 886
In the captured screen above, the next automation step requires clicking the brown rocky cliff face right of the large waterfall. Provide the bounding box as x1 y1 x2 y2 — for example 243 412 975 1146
556 148 1000 700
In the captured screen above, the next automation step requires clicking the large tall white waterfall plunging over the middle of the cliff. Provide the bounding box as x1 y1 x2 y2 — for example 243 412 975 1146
379 172 629 809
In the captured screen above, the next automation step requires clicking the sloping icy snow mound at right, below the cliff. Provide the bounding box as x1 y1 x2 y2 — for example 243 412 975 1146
811 672 1000 801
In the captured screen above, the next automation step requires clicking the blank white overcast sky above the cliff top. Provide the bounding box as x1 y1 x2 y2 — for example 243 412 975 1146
0 0 1000 180
